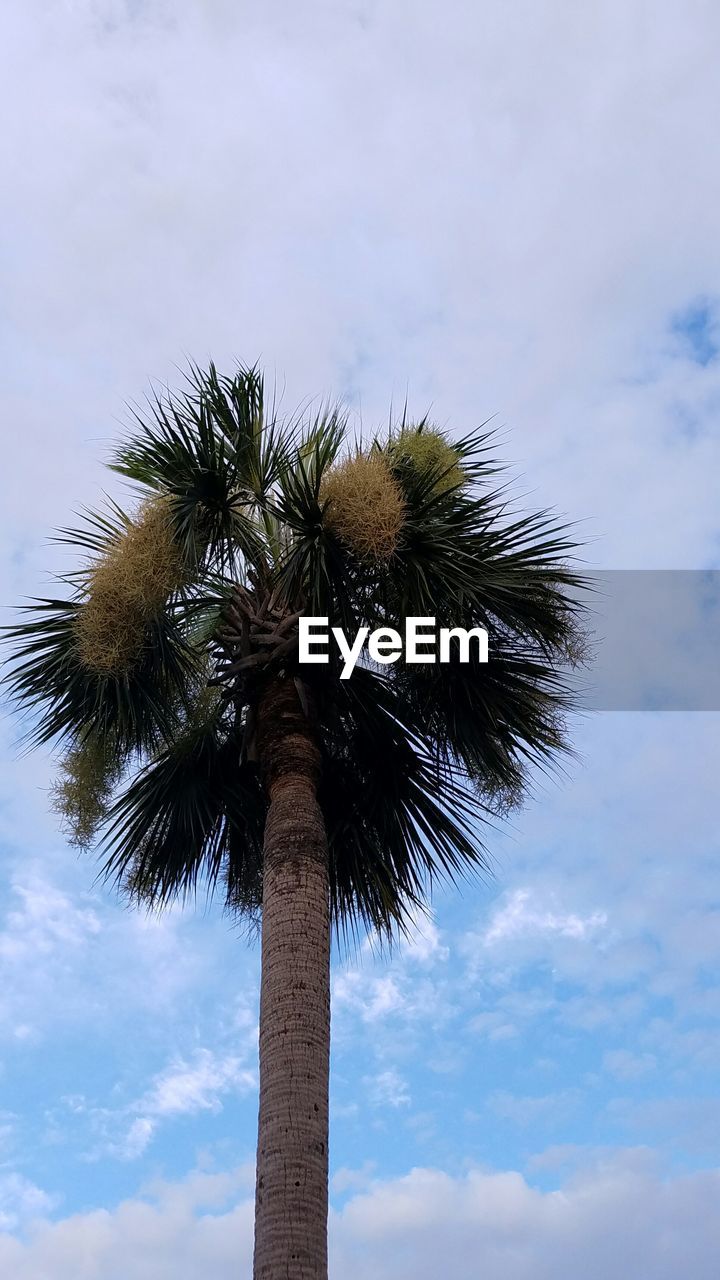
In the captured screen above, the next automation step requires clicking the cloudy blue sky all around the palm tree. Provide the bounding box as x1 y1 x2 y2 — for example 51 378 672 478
0 0 720 1280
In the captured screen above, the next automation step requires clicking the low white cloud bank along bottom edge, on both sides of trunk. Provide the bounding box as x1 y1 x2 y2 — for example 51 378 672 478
0 1153 720 1280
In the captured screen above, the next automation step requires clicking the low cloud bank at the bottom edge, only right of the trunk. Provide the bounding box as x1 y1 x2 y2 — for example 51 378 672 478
334 1162 720 1280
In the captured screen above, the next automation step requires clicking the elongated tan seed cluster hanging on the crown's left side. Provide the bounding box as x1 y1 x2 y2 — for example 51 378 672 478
77 498 183 675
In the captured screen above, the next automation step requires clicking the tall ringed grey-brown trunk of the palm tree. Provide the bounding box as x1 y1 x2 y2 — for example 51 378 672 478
254 678 331 1280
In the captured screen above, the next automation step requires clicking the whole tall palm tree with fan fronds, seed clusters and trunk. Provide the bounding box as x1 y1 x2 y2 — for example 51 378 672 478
6 365 578 1280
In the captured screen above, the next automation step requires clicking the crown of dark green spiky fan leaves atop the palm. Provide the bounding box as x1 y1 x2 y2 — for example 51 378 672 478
5 365 582 936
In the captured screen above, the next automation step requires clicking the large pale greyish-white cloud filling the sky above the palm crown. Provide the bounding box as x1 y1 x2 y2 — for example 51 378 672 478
3 0 720 582
